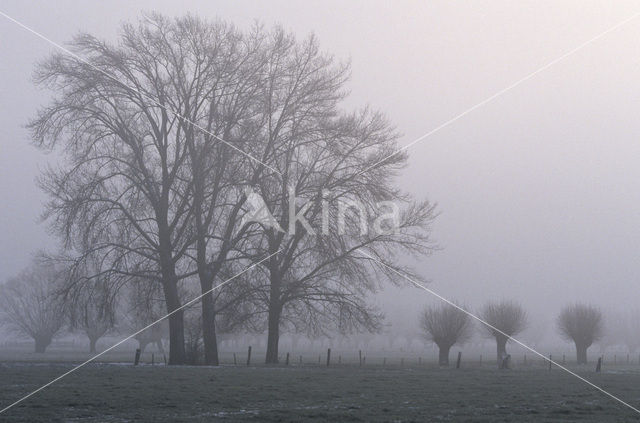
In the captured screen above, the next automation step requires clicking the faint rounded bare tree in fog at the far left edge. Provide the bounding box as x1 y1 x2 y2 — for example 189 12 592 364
0 264 65 353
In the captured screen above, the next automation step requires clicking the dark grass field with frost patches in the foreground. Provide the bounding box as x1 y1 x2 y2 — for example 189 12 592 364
0 362 640 422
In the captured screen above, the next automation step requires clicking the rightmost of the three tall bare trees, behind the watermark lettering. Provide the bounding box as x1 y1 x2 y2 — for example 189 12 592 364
244 29 434 363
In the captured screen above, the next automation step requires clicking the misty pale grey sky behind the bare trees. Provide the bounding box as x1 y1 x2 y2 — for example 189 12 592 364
0 0 640 321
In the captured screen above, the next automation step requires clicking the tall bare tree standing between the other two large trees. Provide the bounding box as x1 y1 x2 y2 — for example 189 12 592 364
175 19 273 365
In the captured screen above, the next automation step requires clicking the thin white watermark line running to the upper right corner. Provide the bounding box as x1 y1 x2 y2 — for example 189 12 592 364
359 12 640 175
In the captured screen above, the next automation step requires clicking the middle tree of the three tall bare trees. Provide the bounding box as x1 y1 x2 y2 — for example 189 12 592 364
122 14 272 365
